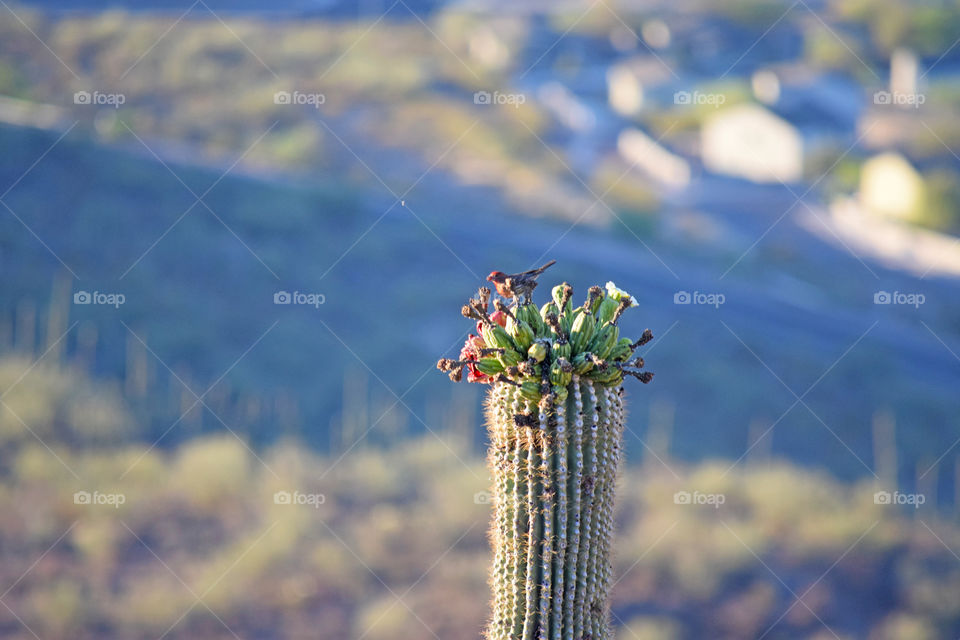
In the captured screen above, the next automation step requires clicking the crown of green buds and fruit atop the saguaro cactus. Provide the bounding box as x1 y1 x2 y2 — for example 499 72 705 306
437 272 653 408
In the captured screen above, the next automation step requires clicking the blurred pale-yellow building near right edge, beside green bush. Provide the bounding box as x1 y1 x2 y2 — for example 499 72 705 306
858 152 926 221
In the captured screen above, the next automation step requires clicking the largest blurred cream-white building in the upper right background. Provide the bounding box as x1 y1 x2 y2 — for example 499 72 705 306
700 104 804 183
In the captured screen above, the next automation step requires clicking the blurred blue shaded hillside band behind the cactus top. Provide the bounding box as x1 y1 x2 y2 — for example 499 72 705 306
0 116 958 496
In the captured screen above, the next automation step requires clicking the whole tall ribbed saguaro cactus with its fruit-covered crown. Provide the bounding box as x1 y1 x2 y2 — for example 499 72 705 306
437 282 653 640
